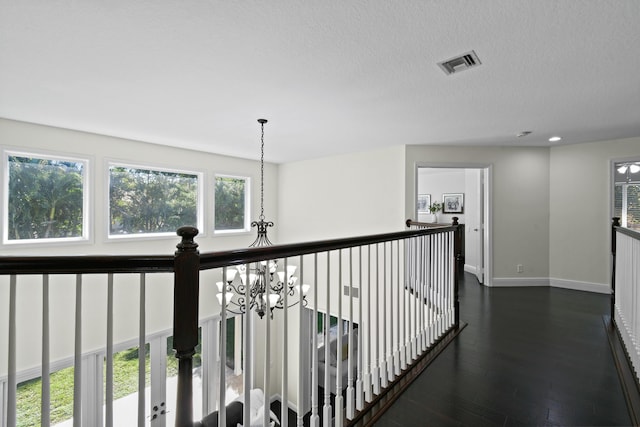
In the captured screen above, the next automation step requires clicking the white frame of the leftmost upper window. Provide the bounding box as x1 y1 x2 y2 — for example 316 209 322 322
0 149 93 246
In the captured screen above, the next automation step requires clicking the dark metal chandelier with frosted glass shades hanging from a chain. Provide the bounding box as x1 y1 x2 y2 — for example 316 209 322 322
216 119 309 318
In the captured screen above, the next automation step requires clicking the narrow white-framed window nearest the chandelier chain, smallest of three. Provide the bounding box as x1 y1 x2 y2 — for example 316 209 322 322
214 175 249 232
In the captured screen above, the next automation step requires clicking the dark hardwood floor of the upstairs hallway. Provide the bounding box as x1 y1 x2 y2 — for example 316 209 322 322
375 274 631 427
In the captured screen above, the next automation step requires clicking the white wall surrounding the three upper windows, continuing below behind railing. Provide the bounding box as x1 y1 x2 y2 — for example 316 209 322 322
0 119 278 376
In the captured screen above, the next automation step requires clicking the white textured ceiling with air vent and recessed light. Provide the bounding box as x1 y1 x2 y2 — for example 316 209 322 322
0 0 640 162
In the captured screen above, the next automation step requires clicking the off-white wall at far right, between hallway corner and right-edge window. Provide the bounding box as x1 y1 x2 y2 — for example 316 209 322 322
549 138 640 292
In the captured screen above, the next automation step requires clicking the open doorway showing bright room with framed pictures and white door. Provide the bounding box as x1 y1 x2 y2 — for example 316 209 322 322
414 163 492 286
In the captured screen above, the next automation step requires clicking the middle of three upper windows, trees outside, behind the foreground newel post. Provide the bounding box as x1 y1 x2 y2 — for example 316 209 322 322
109 165 201 238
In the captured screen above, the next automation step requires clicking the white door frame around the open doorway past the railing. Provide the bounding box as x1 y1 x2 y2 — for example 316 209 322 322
412 161 493 286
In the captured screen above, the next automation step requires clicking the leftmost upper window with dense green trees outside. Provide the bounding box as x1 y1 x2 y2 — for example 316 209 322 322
3 153 89 243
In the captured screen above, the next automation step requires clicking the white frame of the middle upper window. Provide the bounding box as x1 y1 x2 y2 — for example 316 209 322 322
105 159 205 242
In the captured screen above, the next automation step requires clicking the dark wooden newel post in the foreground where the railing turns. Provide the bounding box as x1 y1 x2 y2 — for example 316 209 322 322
173 227 200 427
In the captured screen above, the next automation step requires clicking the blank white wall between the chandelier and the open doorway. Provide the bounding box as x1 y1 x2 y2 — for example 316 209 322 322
278 146 408 243
